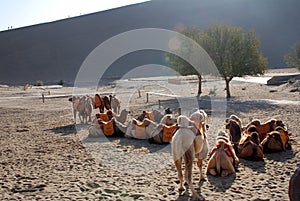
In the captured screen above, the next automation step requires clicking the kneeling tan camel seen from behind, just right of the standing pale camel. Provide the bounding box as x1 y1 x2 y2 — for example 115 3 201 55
206 131 239 177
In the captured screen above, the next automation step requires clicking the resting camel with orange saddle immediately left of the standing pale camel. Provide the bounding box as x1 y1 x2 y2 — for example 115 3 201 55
149 114 177 144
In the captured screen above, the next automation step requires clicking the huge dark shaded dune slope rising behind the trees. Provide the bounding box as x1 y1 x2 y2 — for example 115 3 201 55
0 0 300 84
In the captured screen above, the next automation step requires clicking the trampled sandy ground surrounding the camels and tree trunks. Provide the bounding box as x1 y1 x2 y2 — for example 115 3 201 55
0 68 300 201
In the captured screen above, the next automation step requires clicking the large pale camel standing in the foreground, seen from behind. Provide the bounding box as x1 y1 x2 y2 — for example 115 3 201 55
171 111 208 199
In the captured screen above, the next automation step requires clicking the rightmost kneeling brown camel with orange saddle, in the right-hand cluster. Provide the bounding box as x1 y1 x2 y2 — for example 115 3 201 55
261 126 289 153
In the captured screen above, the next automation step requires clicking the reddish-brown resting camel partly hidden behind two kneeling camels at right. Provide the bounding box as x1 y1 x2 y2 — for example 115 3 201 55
244 119 285 141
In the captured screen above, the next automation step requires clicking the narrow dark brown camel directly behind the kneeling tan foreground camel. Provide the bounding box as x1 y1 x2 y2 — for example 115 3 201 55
225 116 242 152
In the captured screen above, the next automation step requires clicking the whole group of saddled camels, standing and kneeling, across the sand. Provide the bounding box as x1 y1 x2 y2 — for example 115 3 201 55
69 94 291 198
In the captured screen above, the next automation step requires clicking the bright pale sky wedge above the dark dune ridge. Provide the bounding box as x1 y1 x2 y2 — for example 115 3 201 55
0 0 147 31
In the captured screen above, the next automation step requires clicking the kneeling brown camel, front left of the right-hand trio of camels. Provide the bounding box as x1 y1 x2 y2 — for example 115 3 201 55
238 131 264 160
